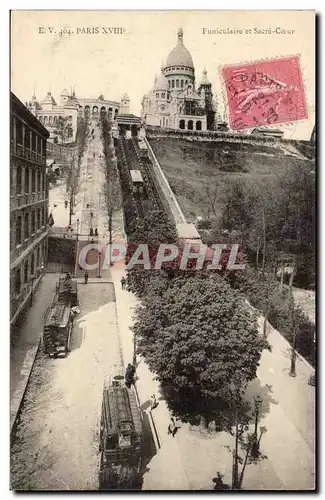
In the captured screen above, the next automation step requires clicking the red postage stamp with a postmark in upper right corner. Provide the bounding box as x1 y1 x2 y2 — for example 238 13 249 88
222 56 308 130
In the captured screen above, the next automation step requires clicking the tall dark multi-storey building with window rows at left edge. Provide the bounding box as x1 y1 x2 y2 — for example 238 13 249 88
10 93 49 324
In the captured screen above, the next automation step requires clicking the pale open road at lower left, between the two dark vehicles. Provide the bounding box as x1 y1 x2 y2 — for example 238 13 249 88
11 283 121 490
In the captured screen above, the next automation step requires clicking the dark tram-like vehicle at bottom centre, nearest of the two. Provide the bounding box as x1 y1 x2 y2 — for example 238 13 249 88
99 376 142 490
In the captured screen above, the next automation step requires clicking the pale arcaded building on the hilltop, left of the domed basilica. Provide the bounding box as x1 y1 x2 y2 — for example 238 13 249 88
26 89 130 142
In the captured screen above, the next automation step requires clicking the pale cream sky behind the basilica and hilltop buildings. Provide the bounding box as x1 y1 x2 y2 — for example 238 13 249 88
11 11 315 140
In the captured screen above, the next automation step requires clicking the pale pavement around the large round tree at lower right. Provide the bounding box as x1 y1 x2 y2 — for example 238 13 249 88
111 263 315 490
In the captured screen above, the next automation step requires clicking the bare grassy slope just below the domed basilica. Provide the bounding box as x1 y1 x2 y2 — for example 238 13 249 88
148 137 304 222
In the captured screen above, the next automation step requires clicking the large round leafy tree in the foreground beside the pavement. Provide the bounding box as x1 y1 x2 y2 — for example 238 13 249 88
134 275 268 426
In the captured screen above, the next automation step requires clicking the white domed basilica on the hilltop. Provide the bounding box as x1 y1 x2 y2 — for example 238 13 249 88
141 28 215 130
